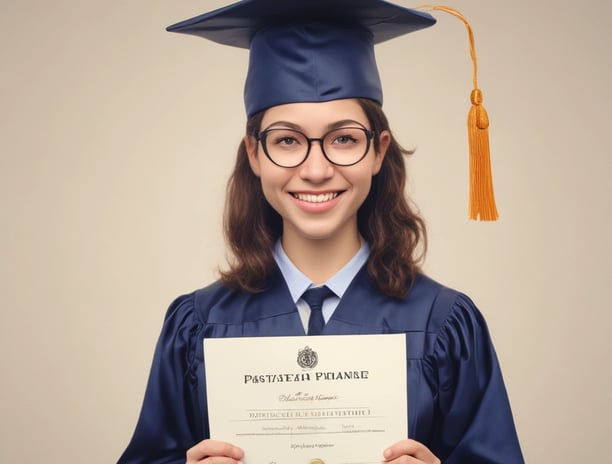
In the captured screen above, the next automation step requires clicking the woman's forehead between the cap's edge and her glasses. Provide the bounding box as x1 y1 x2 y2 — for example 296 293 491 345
262 99 369 131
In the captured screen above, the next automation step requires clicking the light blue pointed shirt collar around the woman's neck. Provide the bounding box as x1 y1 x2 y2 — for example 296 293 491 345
272 239 370 303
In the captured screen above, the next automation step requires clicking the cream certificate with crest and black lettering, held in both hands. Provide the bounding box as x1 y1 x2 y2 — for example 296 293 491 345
204 334 408 464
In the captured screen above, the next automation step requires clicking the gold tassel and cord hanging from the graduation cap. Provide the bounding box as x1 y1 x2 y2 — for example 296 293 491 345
418 5 499 221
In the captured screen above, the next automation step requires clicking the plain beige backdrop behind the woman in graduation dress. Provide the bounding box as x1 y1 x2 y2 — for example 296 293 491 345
0 0 612 463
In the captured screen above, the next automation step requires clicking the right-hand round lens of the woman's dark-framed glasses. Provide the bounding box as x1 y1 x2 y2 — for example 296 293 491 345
323 127 370 166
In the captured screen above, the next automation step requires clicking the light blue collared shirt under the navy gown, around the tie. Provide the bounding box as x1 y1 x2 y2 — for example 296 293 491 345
272 240 370 331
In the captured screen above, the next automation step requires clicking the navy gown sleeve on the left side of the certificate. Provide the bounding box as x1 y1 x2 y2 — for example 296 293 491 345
118 295 204 464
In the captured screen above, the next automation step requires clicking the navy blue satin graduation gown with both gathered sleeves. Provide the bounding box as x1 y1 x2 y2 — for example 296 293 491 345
119 267 524 464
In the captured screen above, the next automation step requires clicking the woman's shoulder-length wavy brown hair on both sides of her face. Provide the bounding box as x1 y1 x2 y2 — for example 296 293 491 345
220 99 427 298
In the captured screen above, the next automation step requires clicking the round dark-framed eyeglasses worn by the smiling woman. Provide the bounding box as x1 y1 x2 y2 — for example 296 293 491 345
257 127 374 168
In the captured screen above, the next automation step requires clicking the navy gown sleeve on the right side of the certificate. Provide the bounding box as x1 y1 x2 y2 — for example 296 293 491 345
428 294 524 464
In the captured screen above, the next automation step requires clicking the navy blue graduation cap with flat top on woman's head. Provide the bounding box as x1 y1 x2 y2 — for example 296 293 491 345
167 0 497 220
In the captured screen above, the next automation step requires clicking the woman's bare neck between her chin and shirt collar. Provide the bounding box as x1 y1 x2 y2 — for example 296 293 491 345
282 227 361 285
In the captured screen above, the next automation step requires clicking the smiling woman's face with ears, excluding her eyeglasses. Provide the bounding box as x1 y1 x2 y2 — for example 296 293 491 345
245 100 390 256
